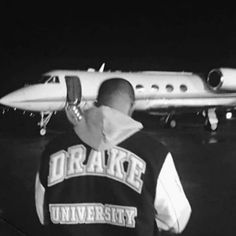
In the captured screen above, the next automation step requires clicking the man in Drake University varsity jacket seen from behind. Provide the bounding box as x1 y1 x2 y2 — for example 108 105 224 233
36 78 191 236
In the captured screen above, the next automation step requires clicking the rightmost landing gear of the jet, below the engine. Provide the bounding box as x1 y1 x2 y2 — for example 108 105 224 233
203 108 219 132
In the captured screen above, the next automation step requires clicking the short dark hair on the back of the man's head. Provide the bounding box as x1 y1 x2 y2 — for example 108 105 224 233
97 78 135 105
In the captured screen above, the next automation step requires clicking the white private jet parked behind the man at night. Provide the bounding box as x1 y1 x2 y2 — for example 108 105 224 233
0 64 236 135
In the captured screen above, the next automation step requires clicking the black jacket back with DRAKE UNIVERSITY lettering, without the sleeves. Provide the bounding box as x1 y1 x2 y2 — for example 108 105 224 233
37 128 167 235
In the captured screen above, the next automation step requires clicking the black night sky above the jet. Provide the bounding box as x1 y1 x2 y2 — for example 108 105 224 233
0 1 236 92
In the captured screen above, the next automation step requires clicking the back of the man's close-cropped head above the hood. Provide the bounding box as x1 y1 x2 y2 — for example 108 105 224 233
97 78 135 116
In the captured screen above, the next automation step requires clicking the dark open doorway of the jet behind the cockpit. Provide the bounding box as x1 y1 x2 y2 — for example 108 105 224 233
65 75 82 105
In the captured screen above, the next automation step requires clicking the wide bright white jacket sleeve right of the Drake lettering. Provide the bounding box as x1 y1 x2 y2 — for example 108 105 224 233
154 153 191 233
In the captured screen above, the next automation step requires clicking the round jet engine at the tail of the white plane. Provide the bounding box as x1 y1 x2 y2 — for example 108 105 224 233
207 68 236 91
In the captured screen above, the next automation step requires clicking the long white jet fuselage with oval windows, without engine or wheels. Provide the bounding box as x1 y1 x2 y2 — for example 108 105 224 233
0 70 236 112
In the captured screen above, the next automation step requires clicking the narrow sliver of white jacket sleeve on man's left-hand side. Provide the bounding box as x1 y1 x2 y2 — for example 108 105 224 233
35 173 45 225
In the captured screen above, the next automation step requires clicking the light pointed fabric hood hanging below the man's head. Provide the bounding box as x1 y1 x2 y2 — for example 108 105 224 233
74 106 143 150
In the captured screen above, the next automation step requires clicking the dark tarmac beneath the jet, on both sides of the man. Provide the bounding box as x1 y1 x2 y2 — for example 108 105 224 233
0 113 236 236
